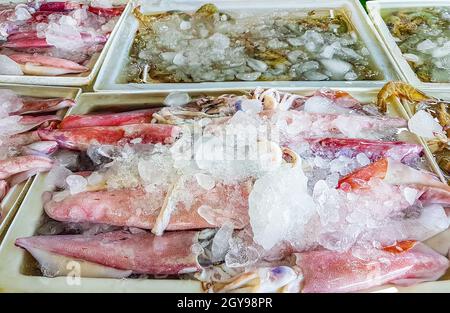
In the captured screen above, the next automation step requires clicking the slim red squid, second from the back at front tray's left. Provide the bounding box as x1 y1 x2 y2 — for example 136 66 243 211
38 124 181 151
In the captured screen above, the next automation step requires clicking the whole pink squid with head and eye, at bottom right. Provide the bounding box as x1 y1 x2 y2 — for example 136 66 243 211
206 241 449 293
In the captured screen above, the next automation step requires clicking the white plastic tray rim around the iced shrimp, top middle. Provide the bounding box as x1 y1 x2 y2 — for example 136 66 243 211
94 0 399 91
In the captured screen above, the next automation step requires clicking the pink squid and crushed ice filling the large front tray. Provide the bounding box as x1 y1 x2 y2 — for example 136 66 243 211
14 84 450 292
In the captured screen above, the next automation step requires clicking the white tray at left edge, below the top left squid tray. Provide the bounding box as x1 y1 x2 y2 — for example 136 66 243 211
0 84 81 241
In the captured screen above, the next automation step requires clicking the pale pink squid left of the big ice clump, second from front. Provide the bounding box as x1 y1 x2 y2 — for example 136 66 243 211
44 180 251 230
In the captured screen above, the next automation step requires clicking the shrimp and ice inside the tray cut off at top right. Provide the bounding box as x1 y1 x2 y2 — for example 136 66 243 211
382 6 450 83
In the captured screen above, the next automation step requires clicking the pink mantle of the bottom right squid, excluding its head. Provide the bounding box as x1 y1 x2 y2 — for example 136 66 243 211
295 242 449 293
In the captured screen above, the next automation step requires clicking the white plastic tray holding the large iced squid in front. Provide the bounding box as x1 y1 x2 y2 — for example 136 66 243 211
0 88 450 292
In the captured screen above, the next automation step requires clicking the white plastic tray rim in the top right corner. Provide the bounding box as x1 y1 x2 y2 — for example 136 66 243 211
366 0 450 91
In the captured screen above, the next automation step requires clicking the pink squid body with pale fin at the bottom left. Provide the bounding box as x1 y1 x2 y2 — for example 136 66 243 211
15 231 201 278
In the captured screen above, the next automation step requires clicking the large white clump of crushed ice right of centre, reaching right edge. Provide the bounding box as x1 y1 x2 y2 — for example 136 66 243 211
249 160 450 255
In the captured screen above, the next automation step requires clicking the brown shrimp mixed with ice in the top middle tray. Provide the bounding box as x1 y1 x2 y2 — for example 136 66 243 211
123 4 383 83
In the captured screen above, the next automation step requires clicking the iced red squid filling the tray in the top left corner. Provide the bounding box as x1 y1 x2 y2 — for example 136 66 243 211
0 0 124 76
